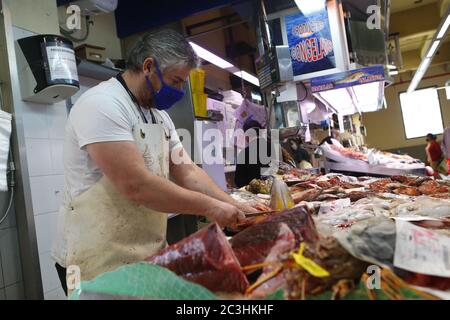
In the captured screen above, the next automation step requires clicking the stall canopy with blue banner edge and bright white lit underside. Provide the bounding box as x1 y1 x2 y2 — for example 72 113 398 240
311 66 386 115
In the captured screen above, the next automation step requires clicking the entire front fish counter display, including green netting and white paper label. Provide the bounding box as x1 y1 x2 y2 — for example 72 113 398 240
71 165 450 300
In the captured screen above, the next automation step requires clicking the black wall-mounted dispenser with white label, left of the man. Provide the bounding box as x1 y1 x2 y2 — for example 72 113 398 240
16 35 80 104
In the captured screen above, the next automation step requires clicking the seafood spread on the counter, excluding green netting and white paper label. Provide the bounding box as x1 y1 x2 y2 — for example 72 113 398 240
148 168 450 299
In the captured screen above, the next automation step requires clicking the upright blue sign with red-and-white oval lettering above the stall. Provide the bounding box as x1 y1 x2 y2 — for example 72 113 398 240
285 7 336 76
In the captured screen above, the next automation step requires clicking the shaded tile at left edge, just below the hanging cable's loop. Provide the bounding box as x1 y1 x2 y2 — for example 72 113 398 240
0 228 22 287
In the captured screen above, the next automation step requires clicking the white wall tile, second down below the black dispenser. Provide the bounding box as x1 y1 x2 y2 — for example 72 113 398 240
25 138 52 177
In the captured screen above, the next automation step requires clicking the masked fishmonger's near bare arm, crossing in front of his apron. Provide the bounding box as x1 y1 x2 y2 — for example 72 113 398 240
86 142 244 225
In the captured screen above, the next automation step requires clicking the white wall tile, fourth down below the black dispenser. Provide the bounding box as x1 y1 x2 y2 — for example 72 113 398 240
34 212 58 254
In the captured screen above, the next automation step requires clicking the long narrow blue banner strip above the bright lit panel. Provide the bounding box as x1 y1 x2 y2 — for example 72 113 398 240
311 65 385 93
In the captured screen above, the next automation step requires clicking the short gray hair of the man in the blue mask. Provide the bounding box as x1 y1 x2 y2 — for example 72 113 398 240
127 29 199 72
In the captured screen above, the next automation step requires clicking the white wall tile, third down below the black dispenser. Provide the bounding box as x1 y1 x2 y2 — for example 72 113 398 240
30 176 59 215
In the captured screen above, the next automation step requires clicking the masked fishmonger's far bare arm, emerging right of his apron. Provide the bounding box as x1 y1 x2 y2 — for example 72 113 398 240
170 148 256 213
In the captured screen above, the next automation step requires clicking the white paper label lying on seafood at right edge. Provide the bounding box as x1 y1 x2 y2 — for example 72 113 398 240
394 220 450 277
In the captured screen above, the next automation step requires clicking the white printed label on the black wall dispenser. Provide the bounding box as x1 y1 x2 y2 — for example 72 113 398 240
46 46 78 81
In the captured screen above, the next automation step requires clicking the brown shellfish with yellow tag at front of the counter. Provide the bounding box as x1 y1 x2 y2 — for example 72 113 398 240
243 237 366 300
